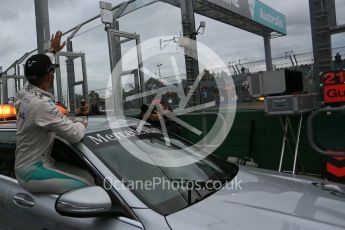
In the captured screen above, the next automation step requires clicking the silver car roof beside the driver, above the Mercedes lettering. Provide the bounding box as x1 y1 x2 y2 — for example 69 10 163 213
0 116 149 133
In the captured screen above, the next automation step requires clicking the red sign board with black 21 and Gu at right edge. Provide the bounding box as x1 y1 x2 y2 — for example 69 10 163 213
322 70 345 103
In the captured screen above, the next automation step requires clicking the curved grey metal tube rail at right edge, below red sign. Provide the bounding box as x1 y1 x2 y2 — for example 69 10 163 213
308 106 345 157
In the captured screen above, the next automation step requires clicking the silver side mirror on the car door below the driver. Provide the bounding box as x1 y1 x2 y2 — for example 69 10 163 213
55 186 112 217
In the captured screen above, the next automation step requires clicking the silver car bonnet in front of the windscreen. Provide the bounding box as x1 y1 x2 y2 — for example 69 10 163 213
167 167 345 230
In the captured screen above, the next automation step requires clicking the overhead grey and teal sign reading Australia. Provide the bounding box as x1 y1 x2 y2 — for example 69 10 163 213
208 0 287 35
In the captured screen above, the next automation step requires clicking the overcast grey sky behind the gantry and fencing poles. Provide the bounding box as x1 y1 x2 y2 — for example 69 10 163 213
0 0 345 93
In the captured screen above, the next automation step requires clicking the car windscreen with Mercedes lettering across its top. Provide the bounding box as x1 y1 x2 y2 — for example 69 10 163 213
83 127 238 215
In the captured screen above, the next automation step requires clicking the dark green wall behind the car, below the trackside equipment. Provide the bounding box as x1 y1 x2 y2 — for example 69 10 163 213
128 109 345 176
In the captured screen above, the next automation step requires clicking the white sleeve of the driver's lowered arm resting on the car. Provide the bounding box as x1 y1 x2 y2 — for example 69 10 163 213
34 100 85 143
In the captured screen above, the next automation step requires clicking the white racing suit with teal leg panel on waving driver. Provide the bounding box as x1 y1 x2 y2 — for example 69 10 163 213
15 83 93 193
